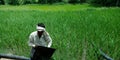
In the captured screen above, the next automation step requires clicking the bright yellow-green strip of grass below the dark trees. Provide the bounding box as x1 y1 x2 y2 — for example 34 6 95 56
0 4 94 11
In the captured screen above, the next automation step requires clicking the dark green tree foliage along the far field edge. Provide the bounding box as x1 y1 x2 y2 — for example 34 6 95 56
0 0 120 6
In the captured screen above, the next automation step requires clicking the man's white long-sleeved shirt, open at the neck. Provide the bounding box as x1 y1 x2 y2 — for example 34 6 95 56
28 31 52 47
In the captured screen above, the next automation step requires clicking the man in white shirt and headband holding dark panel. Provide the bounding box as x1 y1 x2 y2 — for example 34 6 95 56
28 23 52 60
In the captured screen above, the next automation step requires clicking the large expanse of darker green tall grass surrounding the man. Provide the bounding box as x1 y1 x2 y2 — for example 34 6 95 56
0 4 120 60
